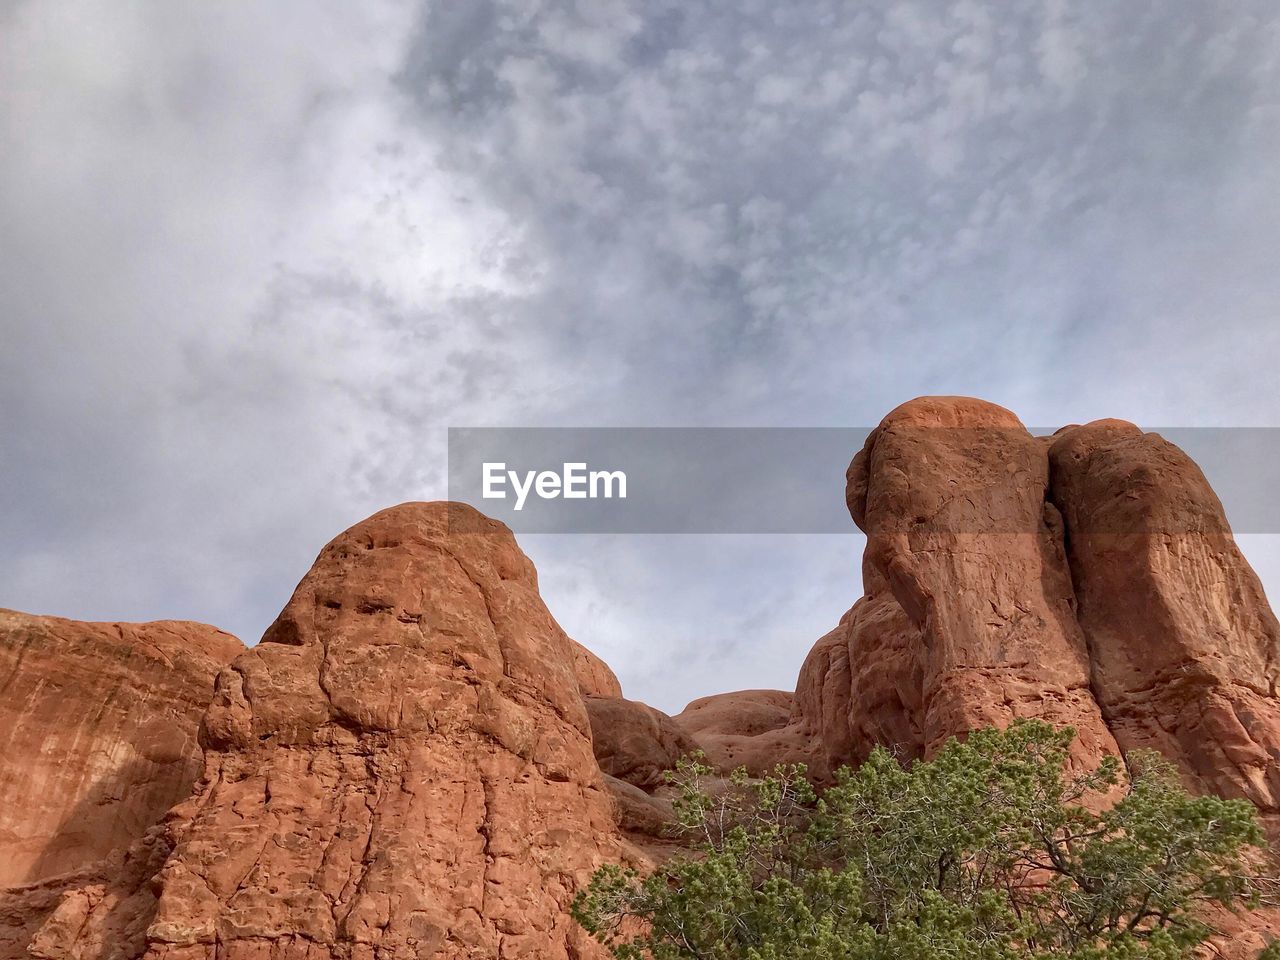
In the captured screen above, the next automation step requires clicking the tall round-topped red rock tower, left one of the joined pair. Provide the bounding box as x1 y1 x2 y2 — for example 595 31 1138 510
797 397 1117 764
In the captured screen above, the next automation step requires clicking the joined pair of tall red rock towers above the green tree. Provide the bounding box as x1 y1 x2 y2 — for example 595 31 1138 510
792 397 1280 823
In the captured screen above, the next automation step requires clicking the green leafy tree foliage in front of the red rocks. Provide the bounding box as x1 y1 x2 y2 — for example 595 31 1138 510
573 721 1280 960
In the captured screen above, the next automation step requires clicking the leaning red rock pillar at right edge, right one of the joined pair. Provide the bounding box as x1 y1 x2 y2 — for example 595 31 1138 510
1050 420 1280 814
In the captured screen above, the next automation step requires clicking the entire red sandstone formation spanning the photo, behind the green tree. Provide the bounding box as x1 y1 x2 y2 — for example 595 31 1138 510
0 397 1280 960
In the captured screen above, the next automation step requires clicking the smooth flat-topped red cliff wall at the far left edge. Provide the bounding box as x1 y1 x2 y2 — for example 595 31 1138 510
0 611 244 957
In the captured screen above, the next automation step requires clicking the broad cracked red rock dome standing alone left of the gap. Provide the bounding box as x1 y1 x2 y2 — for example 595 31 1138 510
128 504 618 960
